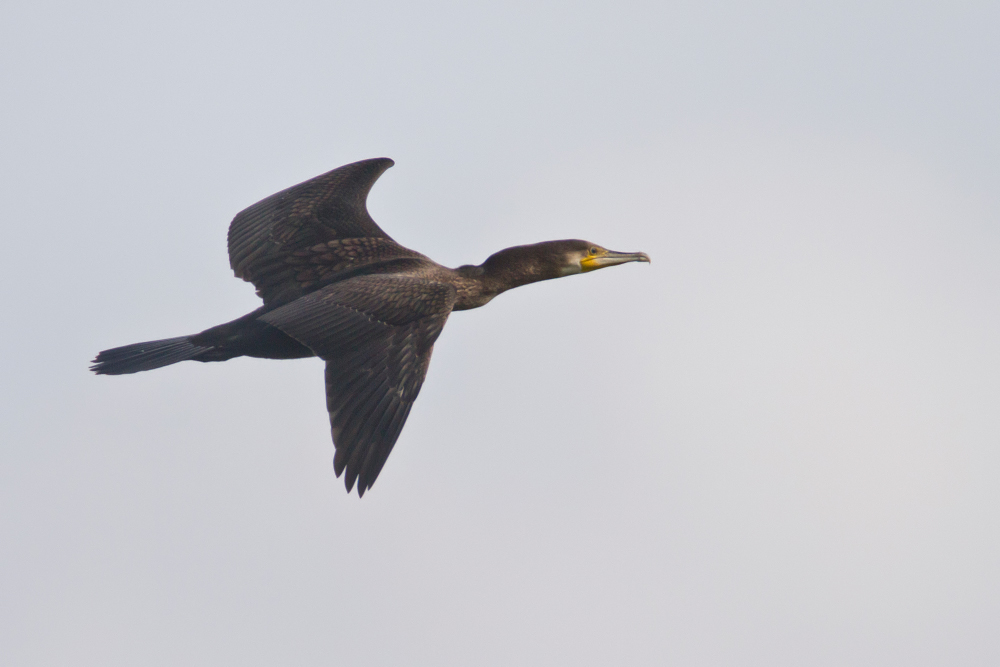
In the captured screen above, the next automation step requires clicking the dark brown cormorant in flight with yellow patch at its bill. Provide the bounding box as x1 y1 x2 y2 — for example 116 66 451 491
91 158 649 496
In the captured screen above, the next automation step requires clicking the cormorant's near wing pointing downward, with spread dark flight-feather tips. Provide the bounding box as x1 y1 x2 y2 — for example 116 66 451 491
261 275 455 496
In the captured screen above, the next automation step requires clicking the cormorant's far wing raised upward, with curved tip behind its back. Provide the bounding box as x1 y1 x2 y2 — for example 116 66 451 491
229 158 422 304
